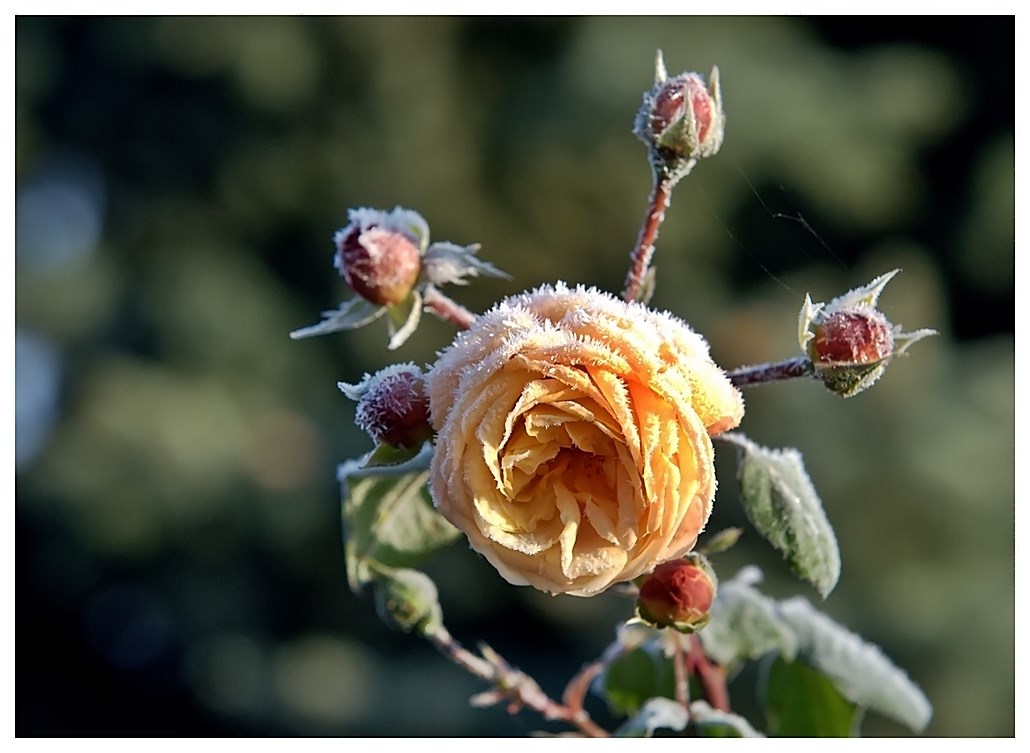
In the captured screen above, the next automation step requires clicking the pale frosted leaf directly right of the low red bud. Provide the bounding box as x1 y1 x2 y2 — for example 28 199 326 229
697 567 797 668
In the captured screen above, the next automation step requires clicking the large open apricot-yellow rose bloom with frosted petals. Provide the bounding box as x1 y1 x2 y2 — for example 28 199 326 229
426 283 744 596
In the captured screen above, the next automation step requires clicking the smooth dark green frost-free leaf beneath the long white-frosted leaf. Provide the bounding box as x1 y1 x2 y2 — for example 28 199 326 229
759 656 862 738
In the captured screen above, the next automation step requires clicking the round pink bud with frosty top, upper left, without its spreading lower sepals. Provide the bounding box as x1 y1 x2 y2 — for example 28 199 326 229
333 207 428 306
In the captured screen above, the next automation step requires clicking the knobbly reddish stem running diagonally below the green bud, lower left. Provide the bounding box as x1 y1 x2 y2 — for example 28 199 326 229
424 625 610 738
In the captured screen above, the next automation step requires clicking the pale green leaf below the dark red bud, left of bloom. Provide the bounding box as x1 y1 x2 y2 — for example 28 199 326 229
337 443 460 592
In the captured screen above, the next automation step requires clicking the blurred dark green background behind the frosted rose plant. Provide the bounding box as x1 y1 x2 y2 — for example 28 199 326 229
15 16 1015 735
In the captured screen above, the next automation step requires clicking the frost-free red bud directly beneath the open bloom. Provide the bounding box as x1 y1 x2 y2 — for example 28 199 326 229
637 553 717 632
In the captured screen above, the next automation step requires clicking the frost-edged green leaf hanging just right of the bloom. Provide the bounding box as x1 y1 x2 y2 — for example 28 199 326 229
723 434 840 598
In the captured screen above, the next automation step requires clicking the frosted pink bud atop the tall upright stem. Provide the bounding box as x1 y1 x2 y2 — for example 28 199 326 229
633 50 726 179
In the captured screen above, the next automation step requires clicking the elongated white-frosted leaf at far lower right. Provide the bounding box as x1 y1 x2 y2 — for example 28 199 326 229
780 597 933 732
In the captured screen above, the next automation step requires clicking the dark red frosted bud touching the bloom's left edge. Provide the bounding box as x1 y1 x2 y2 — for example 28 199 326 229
339 364 433 448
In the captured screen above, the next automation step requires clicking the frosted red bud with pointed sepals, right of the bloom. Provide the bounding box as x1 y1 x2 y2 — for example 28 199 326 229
797 270 936 398
